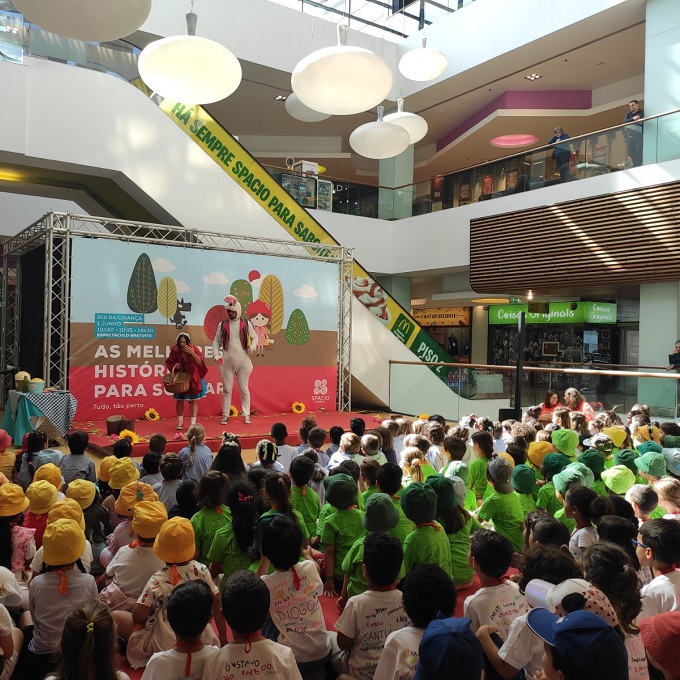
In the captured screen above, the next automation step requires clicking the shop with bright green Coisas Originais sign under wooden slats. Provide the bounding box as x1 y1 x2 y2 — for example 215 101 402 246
488 300 620 366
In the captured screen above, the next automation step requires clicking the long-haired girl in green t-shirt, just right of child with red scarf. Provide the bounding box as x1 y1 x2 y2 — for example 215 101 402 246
426 475 482 589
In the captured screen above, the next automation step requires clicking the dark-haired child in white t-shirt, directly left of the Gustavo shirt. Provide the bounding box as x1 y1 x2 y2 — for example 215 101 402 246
142 580 219 680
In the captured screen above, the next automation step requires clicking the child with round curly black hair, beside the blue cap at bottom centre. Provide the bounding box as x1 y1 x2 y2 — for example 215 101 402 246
373 564 456 680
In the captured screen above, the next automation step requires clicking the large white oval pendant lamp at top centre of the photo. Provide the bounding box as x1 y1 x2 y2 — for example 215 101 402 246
290 25 393 116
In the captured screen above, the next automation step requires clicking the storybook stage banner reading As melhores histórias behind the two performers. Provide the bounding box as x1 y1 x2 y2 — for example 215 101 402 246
69 238 339 420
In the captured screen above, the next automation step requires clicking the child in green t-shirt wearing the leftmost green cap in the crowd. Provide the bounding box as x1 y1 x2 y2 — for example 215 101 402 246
321 472 366 597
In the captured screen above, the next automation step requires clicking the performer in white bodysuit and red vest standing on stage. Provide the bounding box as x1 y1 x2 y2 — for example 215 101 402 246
213 295 257 424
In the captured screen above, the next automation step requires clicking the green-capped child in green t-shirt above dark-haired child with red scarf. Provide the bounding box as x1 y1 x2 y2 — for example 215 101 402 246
477 458 524 552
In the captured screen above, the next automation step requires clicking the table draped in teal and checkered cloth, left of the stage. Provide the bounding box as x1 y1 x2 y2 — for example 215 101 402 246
2 390 78 446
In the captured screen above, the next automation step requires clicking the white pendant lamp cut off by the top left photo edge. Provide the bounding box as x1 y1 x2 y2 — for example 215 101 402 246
12 0 151 42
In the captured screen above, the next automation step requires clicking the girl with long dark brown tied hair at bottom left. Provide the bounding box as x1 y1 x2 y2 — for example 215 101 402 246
46 600 130 680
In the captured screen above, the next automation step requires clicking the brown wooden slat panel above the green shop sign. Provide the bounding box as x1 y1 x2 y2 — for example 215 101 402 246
470 182 680 295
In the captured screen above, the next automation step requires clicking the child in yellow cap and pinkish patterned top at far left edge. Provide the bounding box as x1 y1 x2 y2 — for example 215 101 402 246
0 483 36 581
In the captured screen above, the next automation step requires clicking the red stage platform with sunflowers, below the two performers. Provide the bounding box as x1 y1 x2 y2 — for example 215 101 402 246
71 411 389 457
